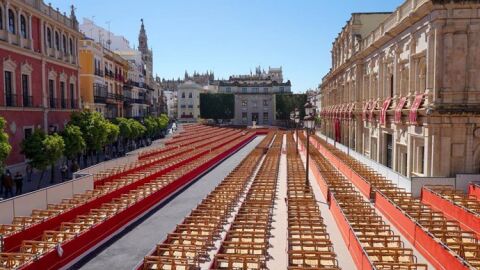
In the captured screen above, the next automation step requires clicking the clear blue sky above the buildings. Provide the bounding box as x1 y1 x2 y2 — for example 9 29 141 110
49 0 403 92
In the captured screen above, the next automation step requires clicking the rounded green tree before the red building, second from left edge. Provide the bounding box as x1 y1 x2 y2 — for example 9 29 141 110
21 129 65 170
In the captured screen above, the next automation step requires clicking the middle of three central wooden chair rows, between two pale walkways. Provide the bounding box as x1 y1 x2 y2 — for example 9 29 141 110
212 133 283 269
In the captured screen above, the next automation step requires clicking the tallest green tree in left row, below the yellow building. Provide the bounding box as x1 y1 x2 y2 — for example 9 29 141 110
70 111 112 150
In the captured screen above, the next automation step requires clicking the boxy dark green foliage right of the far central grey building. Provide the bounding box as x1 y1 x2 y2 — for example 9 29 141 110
275 94 307 120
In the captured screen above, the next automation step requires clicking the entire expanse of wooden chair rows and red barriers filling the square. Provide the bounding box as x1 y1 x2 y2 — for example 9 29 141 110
0 125 480 270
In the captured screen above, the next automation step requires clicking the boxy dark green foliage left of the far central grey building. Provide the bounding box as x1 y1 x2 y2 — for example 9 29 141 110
200 93 235 120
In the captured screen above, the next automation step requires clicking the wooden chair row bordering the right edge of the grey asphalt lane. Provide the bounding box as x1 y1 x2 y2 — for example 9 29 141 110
143 133 269 269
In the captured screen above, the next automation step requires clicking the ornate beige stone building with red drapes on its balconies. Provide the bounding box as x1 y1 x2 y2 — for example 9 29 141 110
320 0 480 177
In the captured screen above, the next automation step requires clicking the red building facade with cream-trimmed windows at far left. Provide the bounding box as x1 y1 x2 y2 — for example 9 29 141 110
0 0 81 165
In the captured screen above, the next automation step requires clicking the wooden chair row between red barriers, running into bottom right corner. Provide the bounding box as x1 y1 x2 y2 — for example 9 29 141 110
315 136 480 267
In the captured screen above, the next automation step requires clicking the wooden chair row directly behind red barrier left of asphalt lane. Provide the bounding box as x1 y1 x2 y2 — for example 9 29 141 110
0 134 251 268
